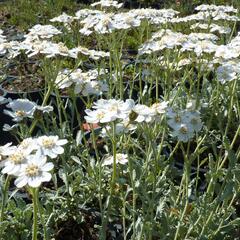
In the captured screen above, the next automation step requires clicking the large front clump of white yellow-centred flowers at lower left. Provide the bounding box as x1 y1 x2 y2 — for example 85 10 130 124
0 136 67 188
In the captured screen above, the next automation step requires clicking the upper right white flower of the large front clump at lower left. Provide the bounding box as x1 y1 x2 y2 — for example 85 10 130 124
36 136 68 158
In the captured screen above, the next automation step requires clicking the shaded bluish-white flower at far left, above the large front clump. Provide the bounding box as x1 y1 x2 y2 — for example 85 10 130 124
4 99 36 122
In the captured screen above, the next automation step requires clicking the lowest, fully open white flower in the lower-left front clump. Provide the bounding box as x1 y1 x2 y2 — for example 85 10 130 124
14 154 54 188
